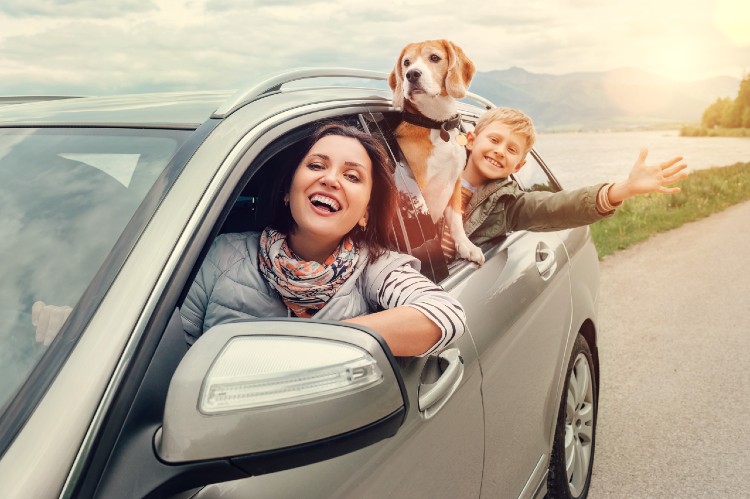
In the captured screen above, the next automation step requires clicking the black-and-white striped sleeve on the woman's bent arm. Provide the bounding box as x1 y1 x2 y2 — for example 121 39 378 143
377 265 466 357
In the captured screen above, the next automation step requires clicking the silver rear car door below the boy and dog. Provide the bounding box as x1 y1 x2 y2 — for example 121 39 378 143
444 146 572 497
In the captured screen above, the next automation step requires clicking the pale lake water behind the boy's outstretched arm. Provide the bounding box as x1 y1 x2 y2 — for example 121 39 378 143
534 130 750 188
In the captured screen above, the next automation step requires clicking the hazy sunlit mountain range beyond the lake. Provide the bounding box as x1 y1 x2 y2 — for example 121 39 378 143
471 67 740 131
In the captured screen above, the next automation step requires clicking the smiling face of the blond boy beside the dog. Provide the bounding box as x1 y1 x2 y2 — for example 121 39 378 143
464 121 527 185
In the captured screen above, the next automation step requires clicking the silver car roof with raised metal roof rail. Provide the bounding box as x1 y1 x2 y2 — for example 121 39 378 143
0 68 491 129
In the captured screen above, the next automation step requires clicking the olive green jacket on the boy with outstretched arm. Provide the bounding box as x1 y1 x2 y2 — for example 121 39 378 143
463 178 614 245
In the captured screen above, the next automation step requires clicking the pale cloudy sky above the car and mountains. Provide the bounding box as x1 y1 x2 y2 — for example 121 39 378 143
0 0 750 96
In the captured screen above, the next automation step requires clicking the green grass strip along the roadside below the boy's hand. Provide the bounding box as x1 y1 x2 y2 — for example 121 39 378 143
591 163 750 259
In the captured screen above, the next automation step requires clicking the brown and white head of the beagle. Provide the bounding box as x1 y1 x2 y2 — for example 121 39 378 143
388 40 475 109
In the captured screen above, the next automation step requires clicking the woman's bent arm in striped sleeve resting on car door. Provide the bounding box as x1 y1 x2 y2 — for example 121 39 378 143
352 265 466 357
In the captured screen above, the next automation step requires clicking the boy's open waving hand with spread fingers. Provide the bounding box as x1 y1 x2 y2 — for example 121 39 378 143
609 147 688 204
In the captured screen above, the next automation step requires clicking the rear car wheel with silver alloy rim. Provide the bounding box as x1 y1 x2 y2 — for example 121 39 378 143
547 335 597 499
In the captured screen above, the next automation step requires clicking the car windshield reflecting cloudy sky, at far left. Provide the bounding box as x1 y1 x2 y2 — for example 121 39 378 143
0 128 190 408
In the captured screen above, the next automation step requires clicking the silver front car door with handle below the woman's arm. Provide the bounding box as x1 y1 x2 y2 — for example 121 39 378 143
183 114 484 498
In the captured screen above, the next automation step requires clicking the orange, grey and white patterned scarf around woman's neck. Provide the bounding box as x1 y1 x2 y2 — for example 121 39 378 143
258 227 359 317
